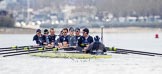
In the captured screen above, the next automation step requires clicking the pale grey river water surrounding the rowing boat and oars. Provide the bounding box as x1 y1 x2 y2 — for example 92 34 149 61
0 32 162 74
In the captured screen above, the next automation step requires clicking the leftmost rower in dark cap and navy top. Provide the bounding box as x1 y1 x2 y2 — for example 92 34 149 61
33 29 43 46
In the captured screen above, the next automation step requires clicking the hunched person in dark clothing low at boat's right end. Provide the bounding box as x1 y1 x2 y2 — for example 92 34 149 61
86 36 106 54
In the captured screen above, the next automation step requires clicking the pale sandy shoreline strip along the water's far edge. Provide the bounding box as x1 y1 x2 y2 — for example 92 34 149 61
0 27 162 34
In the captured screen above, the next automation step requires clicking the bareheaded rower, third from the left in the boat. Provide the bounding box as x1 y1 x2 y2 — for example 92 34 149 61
49 28 57 46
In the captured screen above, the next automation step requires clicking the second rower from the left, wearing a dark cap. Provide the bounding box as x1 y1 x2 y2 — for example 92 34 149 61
43 29 51 46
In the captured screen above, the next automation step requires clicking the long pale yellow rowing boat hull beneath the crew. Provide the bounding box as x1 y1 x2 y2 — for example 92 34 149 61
31 52 112 59
